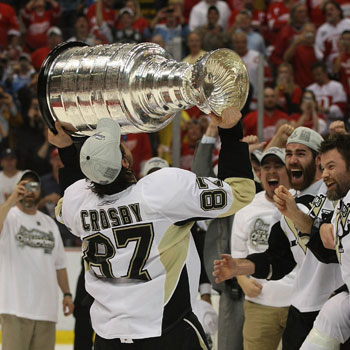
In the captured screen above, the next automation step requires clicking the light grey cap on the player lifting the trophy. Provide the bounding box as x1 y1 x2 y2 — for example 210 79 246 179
80 118 123 185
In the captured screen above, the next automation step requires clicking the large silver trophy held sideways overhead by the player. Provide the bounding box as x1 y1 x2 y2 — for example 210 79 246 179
38 42 249 136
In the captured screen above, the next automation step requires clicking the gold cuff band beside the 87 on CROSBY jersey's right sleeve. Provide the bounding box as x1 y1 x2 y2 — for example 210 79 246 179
219 177 255 217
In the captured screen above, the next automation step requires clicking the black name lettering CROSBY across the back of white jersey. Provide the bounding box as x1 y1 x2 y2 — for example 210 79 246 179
80 203 143 231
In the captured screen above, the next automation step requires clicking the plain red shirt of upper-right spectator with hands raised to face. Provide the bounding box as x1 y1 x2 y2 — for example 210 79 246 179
291 44 317 89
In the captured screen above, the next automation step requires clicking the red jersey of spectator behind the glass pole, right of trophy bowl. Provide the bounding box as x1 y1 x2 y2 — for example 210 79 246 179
243 109 290 141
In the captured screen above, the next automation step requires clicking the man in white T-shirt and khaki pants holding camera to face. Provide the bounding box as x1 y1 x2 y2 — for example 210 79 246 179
0 170 74 350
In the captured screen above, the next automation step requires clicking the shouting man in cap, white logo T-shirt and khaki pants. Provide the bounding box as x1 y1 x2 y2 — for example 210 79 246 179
231 147 295 350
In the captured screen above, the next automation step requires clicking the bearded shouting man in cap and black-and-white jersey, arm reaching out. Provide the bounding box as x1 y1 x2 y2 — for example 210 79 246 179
214 127 343 350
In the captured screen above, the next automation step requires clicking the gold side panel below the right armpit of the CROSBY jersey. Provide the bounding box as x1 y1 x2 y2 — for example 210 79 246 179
158 222 194 305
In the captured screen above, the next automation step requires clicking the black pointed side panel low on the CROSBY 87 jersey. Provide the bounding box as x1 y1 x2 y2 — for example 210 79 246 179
162 265 192 334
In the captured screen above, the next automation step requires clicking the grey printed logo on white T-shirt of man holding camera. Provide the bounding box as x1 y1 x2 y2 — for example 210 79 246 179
15 226 55 254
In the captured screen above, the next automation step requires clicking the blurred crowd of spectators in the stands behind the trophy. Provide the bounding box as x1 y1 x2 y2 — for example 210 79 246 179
0 0 350 246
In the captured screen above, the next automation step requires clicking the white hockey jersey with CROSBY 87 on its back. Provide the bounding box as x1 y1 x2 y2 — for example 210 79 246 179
57 168 255 339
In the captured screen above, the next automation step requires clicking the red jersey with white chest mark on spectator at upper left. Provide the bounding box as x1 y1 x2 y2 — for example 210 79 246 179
21 5 61 51
